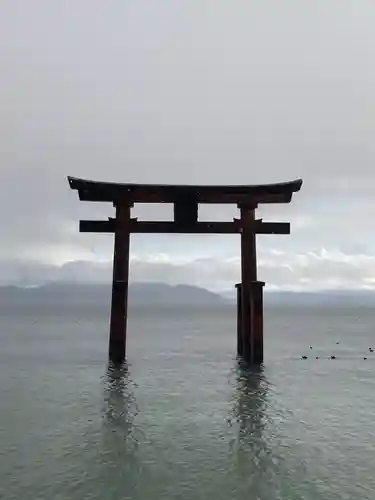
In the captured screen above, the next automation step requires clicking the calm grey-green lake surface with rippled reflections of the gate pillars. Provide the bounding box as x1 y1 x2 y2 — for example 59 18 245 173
0 298 375 500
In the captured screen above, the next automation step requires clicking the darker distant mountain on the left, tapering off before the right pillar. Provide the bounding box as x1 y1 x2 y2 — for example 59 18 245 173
0 283 227 307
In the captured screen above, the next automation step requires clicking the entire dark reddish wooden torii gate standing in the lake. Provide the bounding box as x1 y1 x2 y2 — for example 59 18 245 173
68 177 302 364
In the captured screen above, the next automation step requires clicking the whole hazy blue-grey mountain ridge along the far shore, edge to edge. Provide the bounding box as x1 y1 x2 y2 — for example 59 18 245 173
0 282 375 307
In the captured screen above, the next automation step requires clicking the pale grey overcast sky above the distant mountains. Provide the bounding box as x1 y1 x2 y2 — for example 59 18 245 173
0 0 375 289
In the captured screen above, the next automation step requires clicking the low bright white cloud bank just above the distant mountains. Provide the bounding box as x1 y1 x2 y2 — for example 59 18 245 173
0 250 375 293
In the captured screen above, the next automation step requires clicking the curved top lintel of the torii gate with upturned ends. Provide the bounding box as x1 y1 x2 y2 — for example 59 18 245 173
68 177 302 204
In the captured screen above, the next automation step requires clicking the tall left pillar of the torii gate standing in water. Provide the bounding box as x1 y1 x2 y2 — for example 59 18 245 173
109 203 131 363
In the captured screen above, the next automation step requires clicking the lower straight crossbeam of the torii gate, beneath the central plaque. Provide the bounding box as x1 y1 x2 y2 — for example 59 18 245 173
79 219 290 234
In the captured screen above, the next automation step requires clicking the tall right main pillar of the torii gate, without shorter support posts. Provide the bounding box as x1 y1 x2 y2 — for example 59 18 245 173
239 204 257 363
